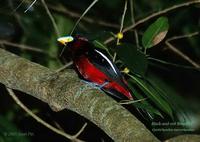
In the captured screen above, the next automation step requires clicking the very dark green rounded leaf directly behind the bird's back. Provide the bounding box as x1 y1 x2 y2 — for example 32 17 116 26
116 43 147 76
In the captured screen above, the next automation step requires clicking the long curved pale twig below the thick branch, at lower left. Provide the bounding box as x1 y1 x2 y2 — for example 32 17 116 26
6 88 85 142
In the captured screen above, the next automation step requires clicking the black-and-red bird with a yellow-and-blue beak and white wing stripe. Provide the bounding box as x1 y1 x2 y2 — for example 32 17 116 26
58 35 133 100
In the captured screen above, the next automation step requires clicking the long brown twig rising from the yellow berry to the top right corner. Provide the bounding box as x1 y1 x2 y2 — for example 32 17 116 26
104 0 200 44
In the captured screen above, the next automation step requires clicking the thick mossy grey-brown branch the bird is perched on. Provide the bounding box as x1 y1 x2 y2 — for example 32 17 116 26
0 49 158 142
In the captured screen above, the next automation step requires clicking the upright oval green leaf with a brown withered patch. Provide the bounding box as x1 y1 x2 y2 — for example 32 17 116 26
142 17 169 49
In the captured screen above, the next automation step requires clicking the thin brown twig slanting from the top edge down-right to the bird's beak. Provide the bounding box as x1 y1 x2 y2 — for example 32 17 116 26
41 0 60 37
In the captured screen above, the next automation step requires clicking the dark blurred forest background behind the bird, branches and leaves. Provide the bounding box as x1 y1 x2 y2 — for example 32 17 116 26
0 0 200 142
